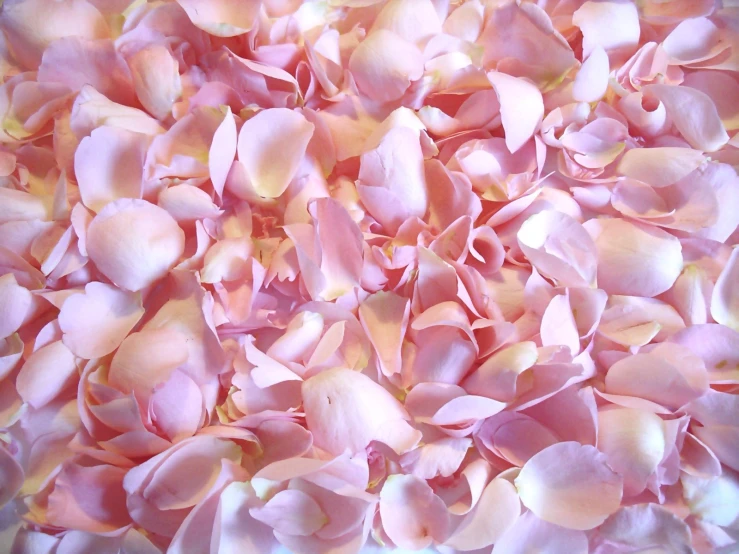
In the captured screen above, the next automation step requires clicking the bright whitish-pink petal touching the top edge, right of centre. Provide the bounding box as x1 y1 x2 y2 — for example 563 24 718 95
572 1 640 57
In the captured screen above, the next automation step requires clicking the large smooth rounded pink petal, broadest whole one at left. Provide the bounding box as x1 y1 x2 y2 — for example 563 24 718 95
87 199 185 292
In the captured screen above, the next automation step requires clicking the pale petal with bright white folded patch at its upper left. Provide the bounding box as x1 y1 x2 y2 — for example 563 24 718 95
517 210 600 286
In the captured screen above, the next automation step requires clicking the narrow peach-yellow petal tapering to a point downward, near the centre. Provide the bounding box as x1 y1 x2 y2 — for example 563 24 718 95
359 292 410 377
